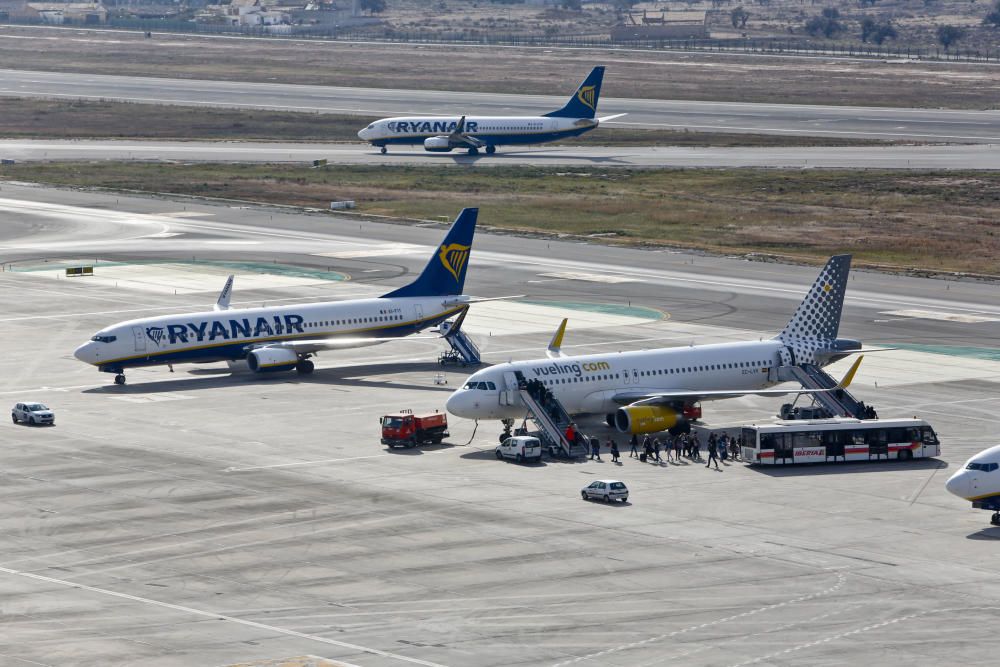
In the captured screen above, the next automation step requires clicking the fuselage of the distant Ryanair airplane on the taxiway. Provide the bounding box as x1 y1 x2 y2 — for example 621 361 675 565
358 116 599 146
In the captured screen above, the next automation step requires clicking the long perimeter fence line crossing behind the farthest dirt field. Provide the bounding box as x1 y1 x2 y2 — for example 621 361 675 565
0 17 1000 63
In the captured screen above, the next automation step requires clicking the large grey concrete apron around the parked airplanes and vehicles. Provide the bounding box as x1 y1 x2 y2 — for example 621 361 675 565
0 183 1000 667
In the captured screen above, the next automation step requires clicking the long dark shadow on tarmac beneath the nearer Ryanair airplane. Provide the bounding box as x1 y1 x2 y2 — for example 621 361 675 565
83 362 457 396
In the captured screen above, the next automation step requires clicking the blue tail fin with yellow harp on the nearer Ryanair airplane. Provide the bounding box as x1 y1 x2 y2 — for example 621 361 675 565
383 208 479 298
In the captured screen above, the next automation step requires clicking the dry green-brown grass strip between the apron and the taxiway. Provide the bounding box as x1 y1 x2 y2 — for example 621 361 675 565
7 162 1000 275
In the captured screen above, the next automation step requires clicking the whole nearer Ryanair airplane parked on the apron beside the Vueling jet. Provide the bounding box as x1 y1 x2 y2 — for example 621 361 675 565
73 208 479 384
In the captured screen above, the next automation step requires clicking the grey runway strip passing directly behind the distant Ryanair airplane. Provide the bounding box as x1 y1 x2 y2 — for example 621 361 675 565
0 69 1000 143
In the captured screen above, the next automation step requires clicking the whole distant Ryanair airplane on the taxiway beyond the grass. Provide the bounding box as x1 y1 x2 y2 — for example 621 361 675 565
358 67 625 155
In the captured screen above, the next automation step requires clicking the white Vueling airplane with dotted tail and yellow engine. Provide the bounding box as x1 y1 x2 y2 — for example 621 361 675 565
447 255 861 433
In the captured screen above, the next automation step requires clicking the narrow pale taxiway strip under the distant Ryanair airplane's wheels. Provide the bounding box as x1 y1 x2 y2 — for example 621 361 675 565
0 140 1000 168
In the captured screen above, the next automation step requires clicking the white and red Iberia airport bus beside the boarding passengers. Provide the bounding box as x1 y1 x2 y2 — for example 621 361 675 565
740 418 941 465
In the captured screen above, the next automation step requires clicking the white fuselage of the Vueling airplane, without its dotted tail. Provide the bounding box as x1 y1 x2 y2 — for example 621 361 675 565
447 340 784 419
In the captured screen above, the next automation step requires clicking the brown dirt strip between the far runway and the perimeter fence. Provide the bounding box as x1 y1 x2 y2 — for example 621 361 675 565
0 25 1000 109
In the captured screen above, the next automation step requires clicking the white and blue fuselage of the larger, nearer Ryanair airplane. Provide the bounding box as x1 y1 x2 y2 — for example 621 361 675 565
74 296 464 373
